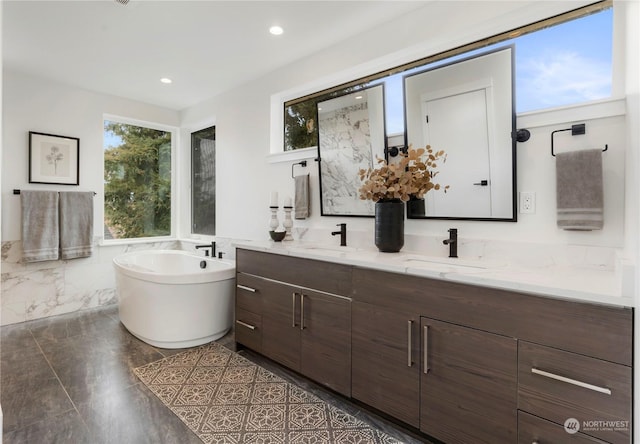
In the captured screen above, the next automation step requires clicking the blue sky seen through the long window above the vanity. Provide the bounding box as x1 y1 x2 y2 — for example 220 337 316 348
385 8 613 134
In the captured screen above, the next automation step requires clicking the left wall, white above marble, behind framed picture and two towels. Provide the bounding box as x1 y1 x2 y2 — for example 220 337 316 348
0 71 179 325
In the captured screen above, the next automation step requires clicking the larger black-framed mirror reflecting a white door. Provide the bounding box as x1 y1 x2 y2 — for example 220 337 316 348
404 46 516 221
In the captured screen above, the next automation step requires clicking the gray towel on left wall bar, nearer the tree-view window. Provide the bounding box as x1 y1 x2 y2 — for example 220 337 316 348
60 191 93 259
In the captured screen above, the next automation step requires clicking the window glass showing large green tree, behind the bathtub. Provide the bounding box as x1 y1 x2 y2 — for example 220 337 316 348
104 119 174 239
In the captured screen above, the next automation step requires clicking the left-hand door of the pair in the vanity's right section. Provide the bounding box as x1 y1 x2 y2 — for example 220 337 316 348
351 301 420 427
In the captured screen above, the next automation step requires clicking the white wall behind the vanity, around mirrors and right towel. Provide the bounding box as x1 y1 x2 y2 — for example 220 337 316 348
182 1 637 254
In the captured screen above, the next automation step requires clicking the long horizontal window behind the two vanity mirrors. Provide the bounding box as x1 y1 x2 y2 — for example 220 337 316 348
283 0 613 151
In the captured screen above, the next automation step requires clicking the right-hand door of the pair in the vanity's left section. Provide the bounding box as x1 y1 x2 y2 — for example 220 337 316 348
300 289 351 396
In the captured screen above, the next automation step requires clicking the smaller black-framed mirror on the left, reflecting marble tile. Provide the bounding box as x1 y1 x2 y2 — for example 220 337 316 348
317 84 386 216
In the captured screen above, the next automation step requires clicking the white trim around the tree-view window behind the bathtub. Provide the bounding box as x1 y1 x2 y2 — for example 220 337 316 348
99 114 180 246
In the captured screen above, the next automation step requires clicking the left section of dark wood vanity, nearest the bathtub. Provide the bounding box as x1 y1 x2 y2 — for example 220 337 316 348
236 250 351 396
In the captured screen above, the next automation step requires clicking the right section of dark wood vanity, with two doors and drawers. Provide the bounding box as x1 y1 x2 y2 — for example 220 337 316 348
352 268 633 444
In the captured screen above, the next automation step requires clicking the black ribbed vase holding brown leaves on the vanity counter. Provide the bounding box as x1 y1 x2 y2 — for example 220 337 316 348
375 199 404 253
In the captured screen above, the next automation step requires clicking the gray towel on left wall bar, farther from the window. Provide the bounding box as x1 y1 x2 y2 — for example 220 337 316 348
20 190 60 262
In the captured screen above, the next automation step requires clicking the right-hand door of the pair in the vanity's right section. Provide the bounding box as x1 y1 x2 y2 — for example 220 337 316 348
420 318 518 444
